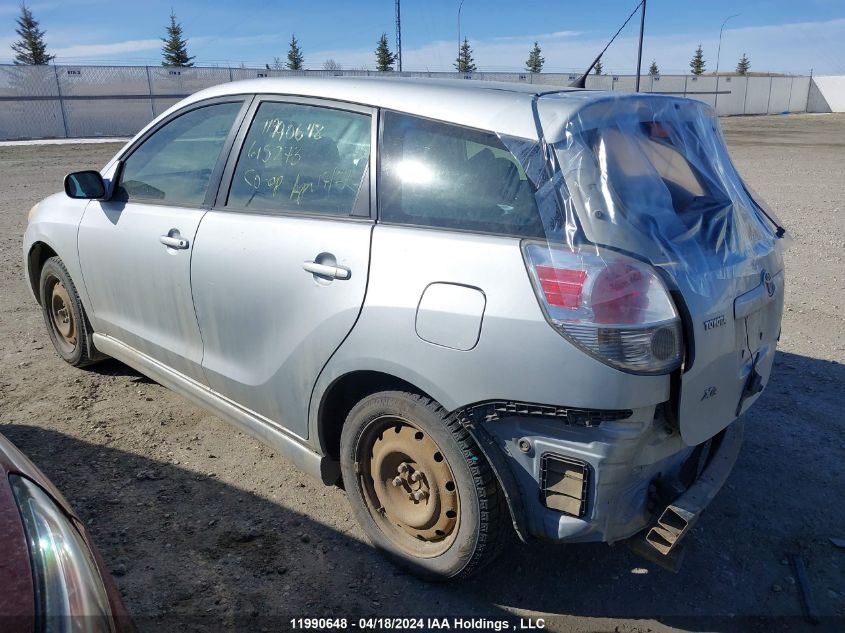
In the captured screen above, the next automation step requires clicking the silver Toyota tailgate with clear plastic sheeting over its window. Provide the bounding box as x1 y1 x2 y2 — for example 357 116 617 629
538 94 784 445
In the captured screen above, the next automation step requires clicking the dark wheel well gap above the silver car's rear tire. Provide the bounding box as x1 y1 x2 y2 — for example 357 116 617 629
317 371 430 461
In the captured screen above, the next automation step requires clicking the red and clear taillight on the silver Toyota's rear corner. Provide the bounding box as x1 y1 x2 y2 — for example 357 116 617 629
523 242 682 374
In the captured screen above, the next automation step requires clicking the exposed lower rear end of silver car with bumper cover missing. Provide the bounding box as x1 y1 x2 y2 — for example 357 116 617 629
464 408 743 552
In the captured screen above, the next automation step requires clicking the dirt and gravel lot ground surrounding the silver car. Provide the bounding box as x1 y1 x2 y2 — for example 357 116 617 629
0 115 845 631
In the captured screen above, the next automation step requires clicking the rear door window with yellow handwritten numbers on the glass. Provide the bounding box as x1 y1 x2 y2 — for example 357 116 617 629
226 101 370 215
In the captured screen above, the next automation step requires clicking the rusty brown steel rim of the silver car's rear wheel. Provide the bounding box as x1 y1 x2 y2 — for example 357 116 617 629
356 416 461 558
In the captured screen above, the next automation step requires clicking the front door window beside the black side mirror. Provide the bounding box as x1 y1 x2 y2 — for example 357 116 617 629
117 102 241 206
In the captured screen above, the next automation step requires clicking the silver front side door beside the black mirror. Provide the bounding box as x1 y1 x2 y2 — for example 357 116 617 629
78 97 247 383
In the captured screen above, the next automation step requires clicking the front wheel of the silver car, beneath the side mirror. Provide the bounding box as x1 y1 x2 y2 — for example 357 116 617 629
39 257 101 367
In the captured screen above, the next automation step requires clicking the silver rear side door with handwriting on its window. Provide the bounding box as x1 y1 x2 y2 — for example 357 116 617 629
191 97 375 437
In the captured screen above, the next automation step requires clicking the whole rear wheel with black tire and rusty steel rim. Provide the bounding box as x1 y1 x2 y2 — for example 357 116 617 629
341 391 508 579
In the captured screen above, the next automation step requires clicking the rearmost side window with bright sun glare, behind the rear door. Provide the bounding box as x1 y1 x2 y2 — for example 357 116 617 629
379 112 544 237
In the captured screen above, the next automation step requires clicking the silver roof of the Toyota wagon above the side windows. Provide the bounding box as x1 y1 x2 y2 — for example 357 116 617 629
176 77 588 139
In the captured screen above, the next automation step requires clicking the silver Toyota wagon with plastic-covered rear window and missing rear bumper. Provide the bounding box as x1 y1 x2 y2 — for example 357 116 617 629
23 78 785 578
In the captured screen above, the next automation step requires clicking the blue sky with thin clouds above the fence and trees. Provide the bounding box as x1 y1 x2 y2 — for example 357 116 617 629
0 0 845 74
